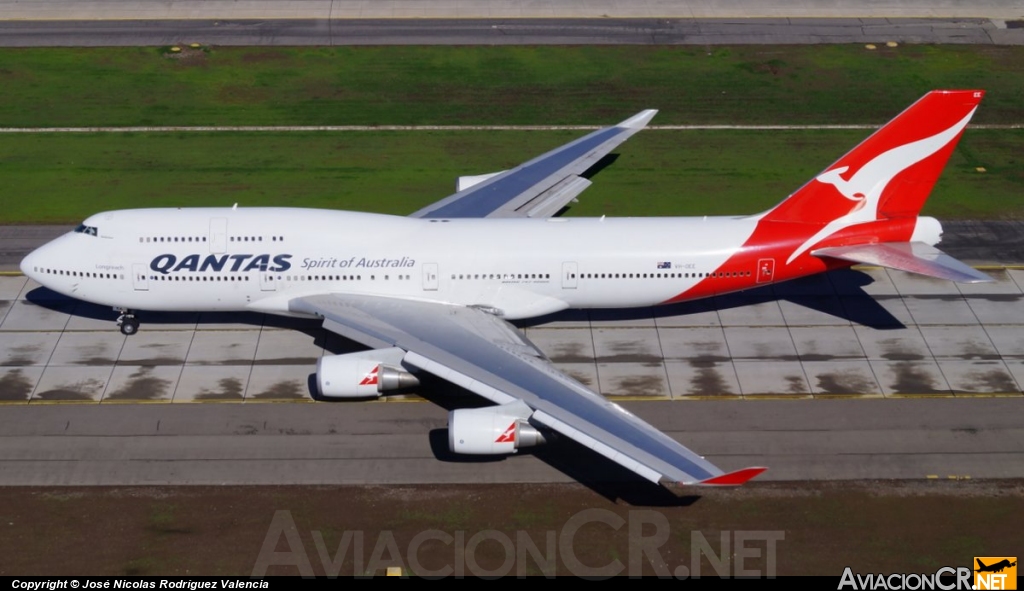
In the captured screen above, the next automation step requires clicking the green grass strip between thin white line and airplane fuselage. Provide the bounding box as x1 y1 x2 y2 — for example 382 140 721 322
0 129 1024 223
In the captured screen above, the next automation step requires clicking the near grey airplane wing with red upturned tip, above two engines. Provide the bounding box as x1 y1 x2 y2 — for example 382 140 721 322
290 294 764 489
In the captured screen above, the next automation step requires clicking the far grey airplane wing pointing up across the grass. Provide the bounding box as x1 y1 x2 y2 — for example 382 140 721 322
411 110 657 219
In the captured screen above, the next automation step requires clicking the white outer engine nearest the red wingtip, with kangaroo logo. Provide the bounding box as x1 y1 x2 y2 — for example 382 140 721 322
449 402 547 456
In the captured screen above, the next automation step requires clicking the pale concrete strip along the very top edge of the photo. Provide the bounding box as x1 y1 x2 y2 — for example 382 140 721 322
0 0 1024 20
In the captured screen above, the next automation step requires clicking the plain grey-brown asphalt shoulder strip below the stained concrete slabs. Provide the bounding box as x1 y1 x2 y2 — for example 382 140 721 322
0 397 1024 486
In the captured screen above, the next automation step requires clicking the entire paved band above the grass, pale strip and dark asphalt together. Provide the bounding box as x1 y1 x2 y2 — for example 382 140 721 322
0 0 1024 47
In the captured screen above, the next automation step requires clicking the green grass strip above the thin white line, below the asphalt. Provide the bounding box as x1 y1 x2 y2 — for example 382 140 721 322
0 45 1024 127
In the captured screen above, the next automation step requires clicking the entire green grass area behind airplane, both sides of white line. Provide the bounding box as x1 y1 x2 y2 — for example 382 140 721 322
0 45 1024 223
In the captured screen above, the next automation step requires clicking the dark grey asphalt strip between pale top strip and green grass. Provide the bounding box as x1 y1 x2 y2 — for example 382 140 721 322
0 16 1024 47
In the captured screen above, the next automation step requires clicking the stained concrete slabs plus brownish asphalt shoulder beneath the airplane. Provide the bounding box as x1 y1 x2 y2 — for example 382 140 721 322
0 268 1024 486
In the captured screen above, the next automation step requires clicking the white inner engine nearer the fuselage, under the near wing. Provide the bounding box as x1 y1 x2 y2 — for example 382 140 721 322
316 348 420 398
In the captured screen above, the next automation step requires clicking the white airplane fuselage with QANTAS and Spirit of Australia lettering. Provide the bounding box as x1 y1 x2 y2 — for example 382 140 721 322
22 208 782 319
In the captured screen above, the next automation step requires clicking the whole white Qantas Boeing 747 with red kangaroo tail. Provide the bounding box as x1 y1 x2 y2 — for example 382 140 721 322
22 90 990 491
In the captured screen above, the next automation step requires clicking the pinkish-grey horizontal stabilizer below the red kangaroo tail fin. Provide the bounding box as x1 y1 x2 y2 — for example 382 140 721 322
811 242 995 283
